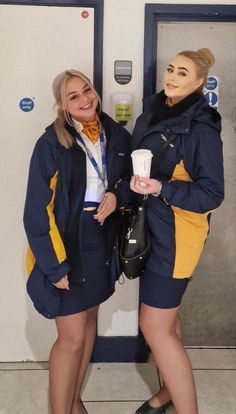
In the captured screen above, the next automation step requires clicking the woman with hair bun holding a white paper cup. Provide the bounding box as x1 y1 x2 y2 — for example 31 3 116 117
130 48 224 414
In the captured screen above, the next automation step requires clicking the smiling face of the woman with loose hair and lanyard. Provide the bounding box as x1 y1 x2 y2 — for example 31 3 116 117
65 76 98 121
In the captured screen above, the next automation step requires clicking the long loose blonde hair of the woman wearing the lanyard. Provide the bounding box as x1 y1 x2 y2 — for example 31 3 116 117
52 69 101 148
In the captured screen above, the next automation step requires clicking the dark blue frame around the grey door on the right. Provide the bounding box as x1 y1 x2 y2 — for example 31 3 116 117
143 3 236 97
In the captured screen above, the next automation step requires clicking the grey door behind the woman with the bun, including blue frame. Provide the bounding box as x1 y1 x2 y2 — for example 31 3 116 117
144 5 236 346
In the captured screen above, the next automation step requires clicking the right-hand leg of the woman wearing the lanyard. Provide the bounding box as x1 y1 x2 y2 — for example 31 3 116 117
71 306 98 414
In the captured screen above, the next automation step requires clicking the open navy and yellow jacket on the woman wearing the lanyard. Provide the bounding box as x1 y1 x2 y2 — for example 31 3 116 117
24 113 131 283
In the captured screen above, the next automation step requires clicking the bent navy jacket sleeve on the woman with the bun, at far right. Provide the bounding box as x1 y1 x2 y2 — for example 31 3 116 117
160 128 224 213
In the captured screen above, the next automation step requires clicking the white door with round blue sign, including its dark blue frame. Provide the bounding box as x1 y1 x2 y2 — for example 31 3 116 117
0 1 102 361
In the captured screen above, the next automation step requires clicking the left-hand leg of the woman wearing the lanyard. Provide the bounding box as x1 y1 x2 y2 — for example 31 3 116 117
49 311 87 414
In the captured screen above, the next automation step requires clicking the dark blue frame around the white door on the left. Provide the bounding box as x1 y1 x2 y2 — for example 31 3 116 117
0 0 104 97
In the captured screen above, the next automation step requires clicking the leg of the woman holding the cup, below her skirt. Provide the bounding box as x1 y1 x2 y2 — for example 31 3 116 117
140 304 198 414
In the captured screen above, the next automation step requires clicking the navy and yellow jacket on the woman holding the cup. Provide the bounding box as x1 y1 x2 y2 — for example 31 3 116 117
131 92 224 278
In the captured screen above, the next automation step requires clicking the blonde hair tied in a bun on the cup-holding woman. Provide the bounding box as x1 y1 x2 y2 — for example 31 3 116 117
177 48 215 92
